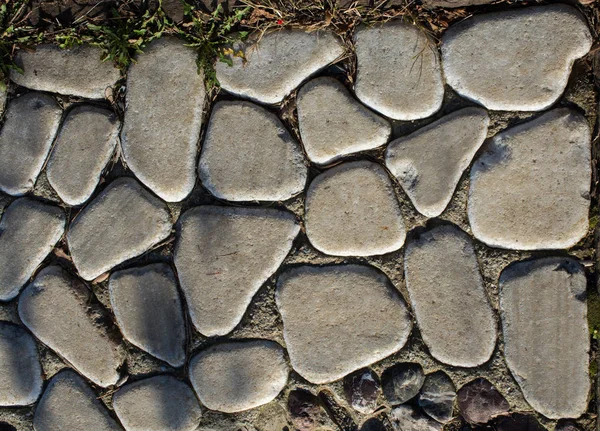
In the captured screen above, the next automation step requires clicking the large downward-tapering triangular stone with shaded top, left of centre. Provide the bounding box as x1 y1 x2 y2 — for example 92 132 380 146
174 205 300 336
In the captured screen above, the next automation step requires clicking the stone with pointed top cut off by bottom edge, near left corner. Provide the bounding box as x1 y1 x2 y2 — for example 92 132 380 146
33 369 122 431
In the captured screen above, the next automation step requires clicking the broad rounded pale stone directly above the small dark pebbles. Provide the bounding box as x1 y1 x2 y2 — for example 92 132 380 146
275 265 412 383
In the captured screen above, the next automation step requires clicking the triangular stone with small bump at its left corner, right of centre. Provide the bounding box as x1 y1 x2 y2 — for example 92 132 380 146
385 108 490 217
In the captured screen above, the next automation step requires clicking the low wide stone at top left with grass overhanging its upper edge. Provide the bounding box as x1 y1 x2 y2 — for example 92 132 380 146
10 44 121 99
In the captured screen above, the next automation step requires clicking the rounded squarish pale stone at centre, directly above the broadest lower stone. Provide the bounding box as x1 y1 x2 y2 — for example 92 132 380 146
305 160 406 256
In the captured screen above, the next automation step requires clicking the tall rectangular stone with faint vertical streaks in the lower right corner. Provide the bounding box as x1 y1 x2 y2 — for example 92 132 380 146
499 257 590 419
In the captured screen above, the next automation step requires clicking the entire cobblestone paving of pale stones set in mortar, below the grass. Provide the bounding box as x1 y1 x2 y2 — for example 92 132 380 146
0 4 598 431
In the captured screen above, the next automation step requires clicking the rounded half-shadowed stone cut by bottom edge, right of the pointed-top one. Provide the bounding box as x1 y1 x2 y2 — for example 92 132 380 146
113 375 202 431
